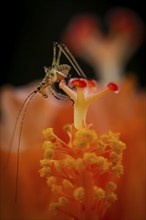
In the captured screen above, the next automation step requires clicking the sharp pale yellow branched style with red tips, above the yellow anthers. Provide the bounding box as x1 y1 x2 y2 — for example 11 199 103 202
60 79 118 129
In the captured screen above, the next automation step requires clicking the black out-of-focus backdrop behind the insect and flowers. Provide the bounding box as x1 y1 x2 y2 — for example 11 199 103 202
1 0 146 88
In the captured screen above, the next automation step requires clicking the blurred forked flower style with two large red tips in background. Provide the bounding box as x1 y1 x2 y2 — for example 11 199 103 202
63 8 144 83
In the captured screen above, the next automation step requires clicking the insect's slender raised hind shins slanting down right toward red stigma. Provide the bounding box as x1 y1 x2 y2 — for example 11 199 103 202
54 42 87 78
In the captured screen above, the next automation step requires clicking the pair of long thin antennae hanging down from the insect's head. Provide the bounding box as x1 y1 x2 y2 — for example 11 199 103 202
12 90 38 202
